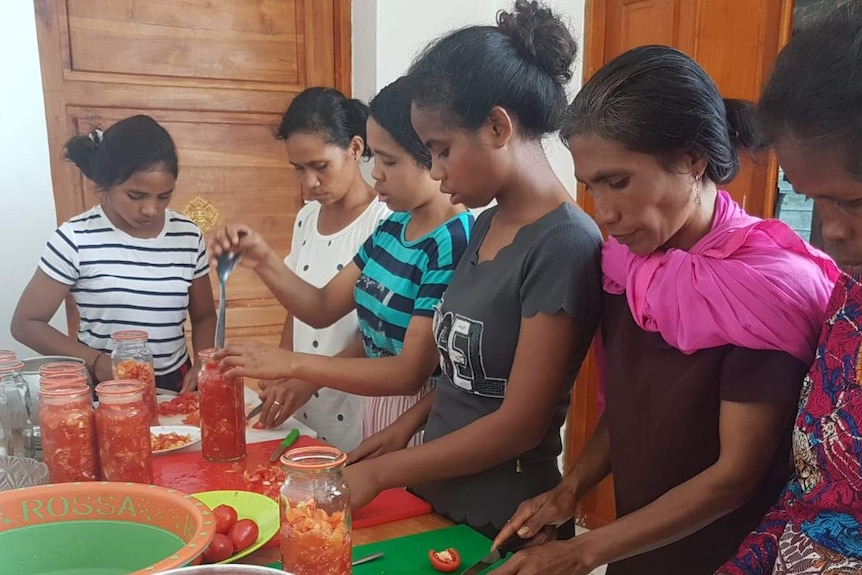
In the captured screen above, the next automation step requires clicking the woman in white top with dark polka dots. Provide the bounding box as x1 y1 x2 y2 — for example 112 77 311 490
260 88 390 451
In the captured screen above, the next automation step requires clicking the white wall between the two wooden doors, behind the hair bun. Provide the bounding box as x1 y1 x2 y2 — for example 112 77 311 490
353 0 584 194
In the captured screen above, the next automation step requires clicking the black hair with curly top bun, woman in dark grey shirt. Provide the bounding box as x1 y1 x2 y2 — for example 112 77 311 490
409 0 577 138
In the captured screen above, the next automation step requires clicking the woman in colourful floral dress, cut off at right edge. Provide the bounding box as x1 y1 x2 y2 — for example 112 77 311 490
718 0 862 575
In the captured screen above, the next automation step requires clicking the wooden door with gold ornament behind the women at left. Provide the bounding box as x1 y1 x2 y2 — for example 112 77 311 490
34 0 350 343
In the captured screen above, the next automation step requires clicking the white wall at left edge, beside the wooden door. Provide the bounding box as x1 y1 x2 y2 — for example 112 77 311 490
0 1 65 357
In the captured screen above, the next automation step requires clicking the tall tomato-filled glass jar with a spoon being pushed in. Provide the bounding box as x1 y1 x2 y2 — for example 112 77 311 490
198 349 246 461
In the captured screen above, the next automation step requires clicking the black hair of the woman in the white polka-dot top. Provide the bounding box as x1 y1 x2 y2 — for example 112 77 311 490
275 87 371 158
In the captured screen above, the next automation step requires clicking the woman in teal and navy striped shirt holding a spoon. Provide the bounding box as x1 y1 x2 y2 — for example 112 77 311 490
210 75 473 447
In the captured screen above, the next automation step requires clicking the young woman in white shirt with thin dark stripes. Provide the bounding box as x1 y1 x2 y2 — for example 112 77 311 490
12 116 216 390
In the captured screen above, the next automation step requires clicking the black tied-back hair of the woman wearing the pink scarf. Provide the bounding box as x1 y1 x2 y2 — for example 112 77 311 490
560 46 764 185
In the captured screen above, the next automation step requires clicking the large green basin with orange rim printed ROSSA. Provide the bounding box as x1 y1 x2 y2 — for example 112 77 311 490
0 481 215 575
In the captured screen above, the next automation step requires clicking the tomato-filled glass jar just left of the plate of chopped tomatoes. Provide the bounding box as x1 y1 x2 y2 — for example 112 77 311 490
96 379 153 483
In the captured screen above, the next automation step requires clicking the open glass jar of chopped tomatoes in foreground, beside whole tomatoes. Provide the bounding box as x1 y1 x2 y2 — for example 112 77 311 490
279 446 351 575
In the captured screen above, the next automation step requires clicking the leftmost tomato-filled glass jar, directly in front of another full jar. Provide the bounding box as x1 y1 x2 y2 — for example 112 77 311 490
39 375 99 483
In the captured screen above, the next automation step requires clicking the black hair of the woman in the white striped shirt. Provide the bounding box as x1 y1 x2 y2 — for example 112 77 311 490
64 115 179 190
